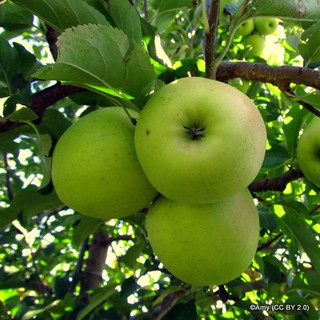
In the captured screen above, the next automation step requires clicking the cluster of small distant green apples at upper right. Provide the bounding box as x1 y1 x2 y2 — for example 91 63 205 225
236 17 278 56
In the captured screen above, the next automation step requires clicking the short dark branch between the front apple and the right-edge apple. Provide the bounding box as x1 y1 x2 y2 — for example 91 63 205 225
249 169 304 192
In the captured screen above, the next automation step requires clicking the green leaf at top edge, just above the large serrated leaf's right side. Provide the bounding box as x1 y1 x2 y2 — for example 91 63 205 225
108 0 142 44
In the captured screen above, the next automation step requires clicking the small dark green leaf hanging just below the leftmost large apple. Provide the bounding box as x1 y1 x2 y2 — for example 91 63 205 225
72 215 103 246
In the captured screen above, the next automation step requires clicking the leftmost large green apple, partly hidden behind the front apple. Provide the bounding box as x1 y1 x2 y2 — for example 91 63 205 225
52 107 157 220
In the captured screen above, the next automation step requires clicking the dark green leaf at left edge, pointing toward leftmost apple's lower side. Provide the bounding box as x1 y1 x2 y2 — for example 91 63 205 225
0 185 62 228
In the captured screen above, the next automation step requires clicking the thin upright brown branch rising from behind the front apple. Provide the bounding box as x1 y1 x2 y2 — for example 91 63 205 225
205 0 220 79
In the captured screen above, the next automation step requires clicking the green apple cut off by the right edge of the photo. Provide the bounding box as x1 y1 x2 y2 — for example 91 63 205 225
297 117 320 187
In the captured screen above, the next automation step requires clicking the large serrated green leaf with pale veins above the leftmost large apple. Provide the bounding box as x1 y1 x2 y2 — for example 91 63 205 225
34 24 155 97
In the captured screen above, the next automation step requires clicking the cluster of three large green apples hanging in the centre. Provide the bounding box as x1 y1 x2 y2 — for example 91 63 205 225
52 77 266 286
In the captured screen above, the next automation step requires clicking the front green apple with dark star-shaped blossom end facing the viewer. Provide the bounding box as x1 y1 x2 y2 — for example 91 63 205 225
135 77 266 203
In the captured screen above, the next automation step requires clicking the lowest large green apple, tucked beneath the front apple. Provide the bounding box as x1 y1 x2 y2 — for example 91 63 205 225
146 189 259 286
